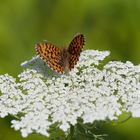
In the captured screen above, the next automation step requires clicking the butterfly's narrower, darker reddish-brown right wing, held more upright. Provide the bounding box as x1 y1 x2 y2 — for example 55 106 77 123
68 34 85 70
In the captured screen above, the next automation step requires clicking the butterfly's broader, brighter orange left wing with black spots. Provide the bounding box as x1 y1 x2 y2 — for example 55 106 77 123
36 43 64 73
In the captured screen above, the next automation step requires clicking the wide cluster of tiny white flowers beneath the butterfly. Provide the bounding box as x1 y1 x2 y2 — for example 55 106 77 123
0 50 140 137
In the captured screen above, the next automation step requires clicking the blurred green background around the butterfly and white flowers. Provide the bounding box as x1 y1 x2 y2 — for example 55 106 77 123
0 0 140 140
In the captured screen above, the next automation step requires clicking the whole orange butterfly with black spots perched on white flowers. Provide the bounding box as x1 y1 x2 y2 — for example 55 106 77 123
35 34 85 74
